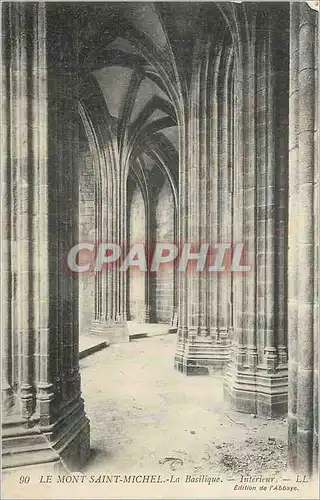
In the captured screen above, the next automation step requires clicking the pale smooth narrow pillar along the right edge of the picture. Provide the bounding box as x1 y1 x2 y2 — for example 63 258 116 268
288 2 319 474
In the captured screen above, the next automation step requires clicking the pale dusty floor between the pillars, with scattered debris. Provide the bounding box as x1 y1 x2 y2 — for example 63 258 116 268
81 335 287 474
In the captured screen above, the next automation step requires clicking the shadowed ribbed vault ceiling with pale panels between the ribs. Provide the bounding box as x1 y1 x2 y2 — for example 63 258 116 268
77 2 235 184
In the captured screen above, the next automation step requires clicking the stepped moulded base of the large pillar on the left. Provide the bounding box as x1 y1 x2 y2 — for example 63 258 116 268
2 399 90 472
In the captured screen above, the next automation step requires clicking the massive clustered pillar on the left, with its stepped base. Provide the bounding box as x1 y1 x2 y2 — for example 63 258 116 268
1 3 90 469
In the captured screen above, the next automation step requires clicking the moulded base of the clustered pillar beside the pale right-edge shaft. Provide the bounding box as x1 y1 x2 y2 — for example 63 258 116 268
224 366 288 418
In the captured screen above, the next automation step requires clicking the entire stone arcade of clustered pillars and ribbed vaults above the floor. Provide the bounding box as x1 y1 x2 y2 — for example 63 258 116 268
1 2 319 480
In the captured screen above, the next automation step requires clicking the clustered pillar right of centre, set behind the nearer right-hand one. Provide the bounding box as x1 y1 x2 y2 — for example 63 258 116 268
175 40 234 375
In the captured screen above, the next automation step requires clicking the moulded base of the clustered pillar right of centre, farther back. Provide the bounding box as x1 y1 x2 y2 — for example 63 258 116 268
174 330 230 375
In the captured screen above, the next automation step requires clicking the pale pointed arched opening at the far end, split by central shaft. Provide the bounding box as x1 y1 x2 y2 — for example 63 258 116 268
127 154 177 326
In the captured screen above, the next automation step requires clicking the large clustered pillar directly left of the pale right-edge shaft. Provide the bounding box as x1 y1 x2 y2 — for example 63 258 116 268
225 7 288 417
